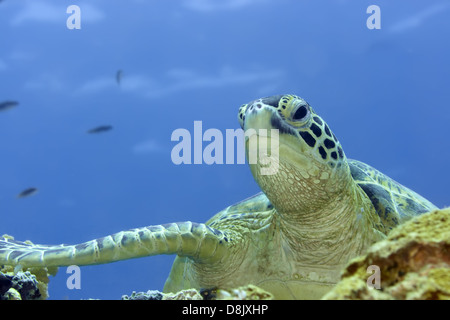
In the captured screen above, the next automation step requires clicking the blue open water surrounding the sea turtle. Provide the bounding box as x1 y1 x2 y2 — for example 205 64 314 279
0 0 450 299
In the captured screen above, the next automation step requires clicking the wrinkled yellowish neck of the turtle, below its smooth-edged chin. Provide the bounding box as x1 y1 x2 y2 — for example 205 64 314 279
278 184 381 265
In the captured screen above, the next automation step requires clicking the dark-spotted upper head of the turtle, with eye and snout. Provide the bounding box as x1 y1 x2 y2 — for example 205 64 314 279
238 95 345 168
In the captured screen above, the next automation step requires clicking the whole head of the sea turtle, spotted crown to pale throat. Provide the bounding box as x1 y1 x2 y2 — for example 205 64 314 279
238 95 351 213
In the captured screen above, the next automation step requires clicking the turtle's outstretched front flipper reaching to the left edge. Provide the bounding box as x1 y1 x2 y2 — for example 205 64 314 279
0 221 228 267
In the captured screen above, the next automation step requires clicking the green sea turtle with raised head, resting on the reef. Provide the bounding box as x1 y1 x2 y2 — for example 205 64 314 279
0 95 436 299
